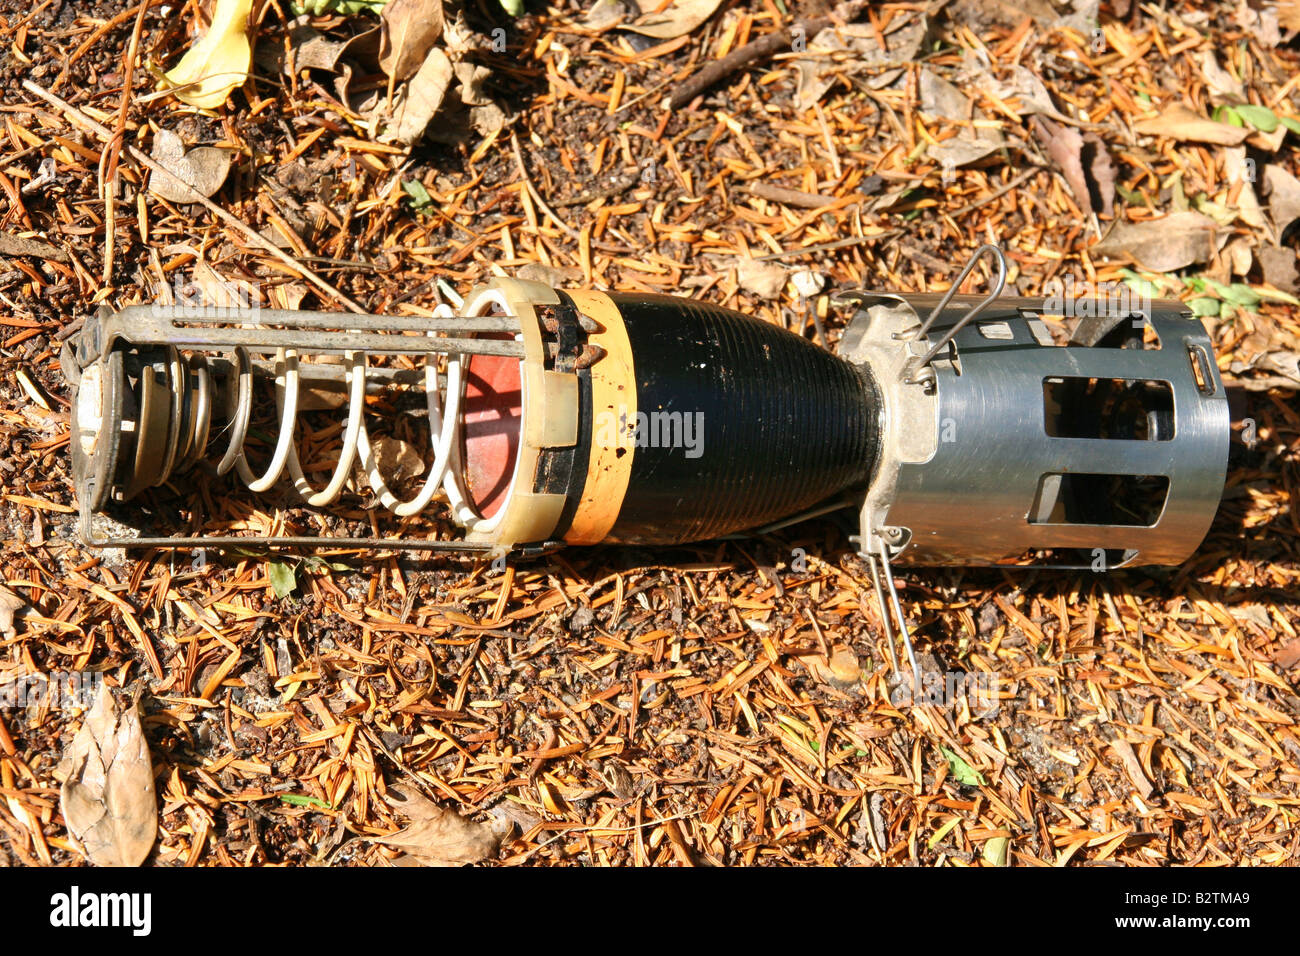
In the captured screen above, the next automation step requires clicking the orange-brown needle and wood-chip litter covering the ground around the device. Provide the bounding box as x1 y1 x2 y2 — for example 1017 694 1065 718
0 0 1300 866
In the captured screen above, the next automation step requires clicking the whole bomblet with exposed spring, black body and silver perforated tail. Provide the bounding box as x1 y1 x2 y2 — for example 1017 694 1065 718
61 246 1230 581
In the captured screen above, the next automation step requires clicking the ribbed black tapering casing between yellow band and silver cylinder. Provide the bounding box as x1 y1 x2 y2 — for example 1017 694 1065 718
610 293 879 544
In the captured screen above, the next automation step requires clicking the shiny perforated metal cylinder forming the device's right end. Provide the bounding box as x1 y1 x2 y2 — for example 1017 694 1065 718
840 295 1230 570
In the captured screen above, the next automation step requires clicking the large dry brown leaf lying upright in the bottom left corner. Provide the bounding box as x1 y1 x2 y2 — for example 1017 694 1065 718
55 684 159 866
